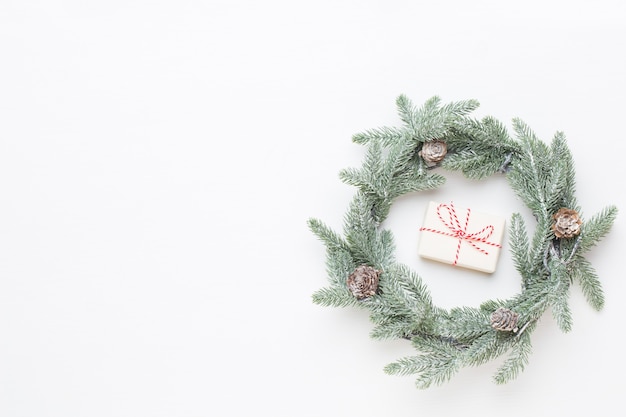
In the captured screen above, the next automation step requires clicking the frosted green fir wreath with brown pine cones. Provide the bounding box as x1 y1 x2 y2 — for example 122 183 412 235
308 95 617 388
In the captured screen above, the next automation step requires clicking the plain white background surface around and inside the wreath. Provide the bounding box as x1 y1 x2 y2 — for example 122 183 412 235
0 0 626 417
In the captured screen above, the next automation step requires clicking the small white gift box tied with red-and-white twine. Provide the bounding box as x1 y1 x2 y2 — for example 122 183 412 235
418 201 505 273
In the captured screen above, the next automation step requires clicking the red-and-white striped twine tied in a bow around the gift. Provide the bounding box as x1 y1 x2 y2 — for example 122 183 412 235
420 203 502 265
